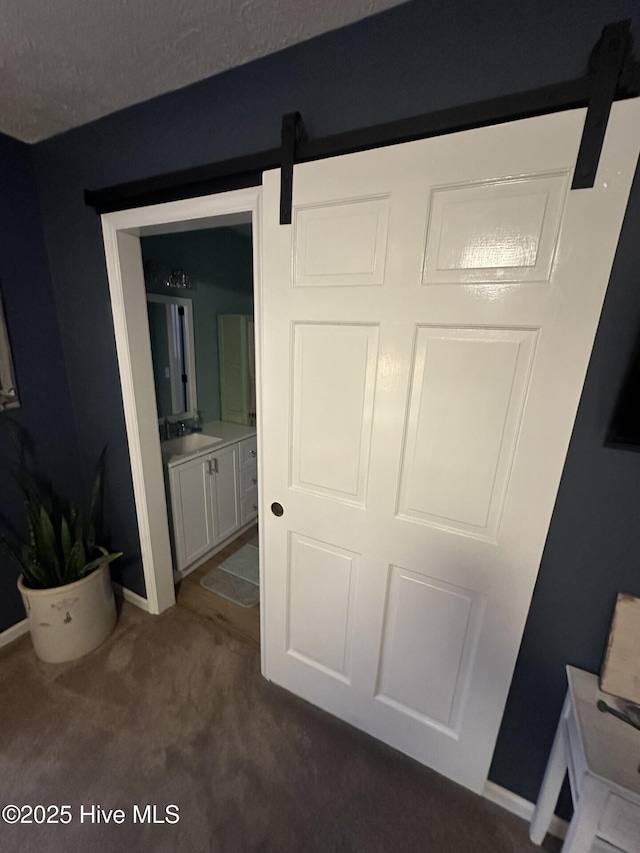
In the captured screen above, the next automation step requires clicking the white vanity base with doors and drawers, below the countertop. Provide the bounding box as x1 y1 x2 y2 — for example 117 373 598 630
168 435 258 571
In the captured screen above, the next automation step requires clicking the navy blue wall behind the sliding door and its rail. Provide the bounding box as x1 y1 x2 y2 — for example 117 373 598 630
27 0 640 799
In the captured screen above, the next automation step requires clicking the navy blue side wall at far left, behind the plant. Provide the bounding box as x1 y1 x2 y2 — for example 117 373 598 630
0 134 79 631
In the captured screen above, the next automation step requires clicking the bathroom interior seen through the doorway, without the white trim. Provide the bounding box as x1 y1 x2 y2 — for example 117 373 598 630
141 222 260 646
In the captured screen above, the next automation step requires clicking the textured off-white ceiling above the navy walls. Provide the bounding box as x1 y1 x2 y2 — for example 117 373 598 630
0 0 405 142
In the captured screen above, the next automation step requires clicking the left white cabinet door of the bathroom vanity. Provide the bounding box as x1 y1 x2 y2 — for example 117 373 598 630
170 457 215 570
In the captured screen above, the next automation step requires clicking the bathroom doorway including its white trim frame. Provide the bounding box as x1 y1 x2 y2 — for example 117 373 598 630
102 187 264 660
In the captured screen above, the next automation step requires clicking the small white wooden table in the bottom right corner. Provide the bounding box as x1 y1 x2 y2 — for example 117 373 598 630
530 666 640 853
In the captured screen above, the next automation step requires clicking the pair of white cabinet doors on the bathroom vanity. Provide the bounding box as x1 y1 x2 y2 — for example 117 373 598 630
169 444 240 571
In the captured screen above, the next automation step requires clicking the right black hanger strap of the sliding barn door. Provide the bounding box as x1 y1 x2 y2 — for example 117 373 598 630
571 20 633 190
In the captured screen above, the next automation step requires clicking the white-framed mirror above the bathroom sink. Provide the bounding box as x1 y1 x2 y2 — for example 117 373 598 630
147 293 198 420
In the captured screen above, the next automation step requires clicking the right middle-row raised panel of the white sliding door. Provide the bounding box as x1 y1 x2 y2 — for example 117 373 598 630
398 326 537 541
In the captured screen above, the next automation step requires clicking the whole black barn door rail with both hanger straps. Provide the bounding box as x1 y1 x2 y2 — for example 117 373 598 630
85 21 640 213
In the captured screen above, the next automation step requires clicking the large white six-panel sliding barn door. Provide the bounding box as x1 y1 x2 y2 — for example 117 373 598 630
260 101 640 791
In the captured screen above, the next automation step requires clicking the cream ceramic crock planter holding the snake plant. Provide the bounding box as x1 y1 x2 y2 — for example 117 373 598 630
18 565 117 663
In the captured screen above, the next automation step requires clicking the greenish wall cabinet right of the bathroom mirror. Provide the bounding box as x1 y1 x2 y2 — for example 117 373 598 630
218 314 256 424
